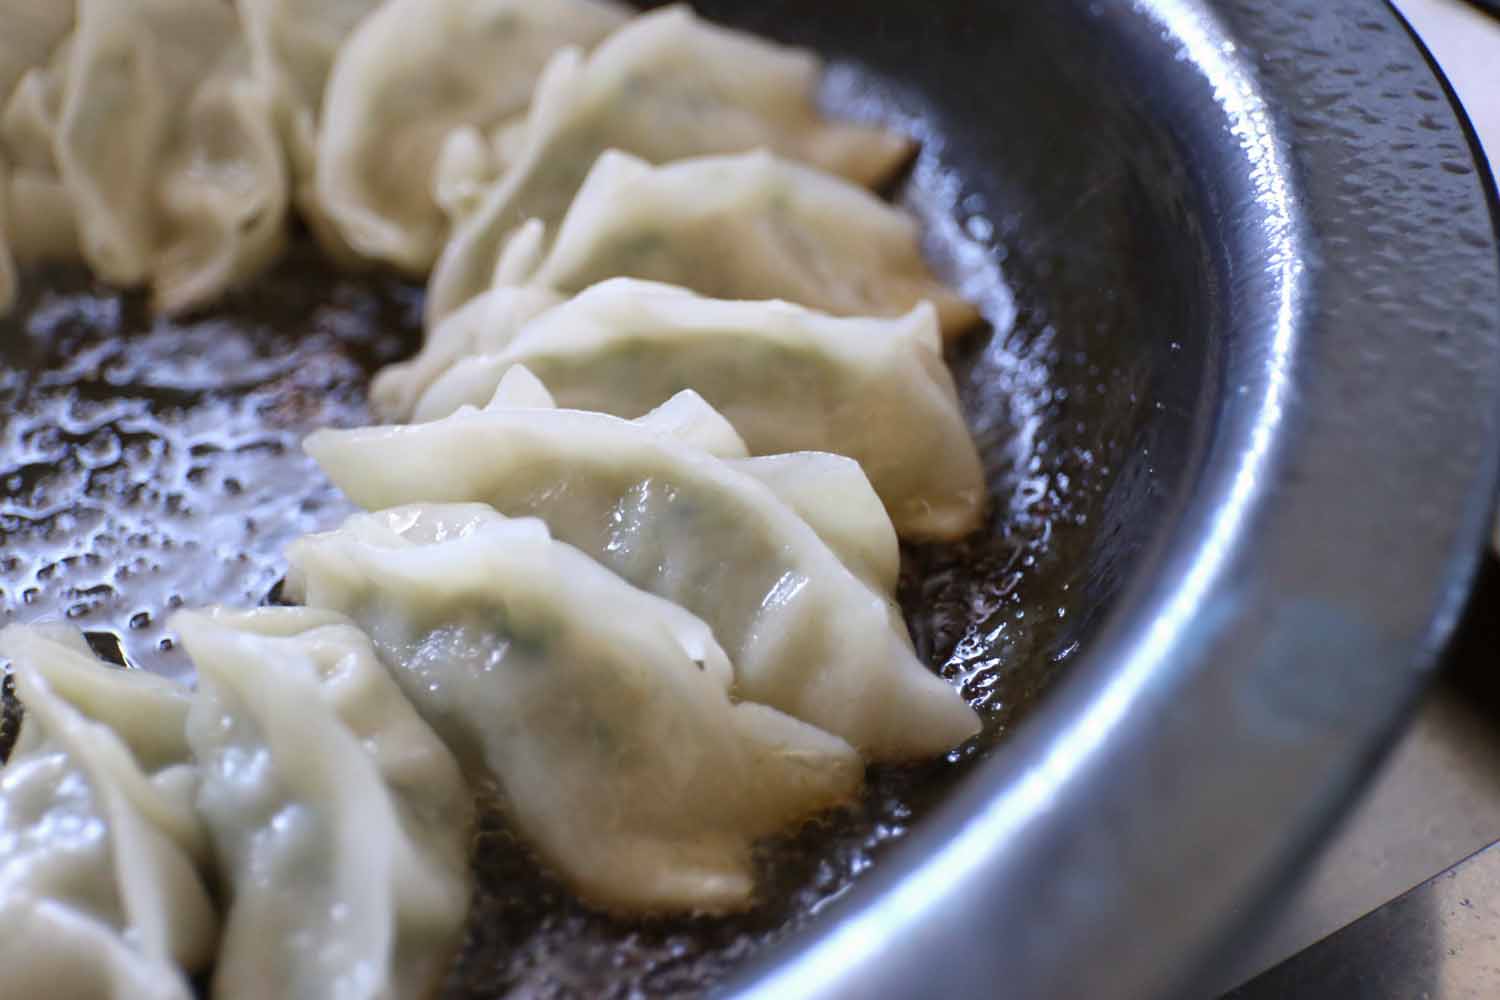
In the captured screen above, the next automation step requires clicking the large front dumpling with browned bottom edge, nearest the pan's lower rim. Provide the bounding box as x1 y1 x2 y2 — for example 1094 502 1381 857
288 504 864 912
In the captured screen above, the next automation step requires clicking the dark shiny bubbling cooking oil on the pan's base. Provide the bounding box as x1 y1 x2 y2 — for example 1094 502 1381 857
0 121 1110 997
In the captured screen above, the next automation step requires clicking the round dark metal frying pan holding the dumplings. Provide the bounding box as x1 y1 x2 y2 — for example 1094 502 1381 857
0 0 1500 997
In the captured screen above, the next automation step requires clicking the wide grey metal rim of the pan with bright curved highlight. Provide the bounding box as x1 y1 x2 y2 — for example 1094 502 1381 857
740 0 1500 999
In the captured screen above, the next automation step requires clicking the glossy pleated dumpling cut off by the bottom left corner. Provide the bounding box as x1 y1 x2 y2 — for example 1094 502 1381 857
0 625 218 1000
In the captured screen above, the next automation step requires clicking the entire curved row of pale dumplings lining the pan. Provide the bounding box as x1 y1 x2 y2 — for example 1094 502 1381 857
0 0 986 999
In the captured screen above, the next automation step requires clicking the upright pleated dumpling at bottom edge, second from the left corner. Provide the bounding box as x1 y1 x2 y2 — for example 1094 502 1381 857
170 609 473 1000
